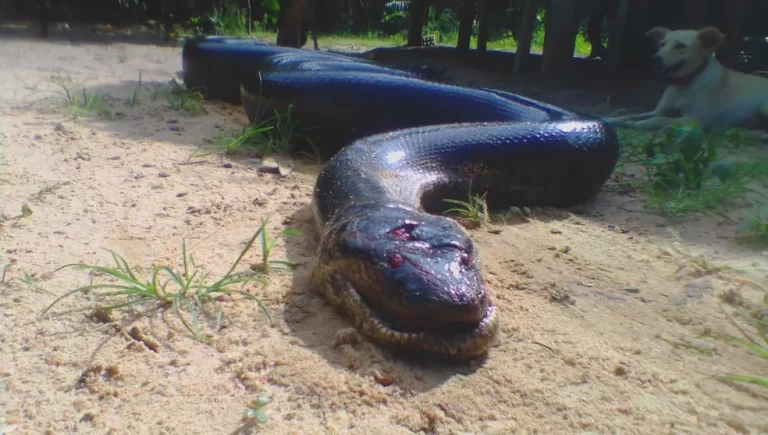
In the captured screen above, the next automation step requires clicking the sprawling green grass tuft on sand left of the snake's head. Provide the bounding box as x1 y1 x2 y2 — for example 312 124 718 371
40 219 296 341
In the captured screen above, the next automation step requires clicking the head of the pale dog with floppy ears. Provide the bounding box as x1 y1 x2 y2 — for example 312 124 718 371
645 26 725 78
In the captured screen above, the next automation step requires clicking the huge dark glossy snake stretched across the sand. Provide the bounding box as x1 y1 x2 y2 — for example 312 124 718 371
185 37 619 358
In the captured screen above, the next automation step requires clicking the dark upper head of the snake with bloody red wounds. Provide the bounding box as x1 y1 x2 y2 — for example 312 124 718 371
330 206 492 341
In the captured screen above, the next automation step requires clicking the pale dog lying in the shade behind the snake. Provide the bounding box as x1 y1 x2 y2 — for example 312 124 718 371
605 27 768 138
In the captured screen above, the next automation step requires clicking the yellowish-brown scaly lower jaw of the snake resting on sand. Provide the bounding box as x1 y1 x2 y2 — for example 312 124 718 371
329 273 500 358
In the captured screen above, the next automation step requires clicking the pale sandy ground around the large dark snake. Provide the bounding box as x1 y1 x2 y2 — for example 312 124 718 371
0 29 768 435
